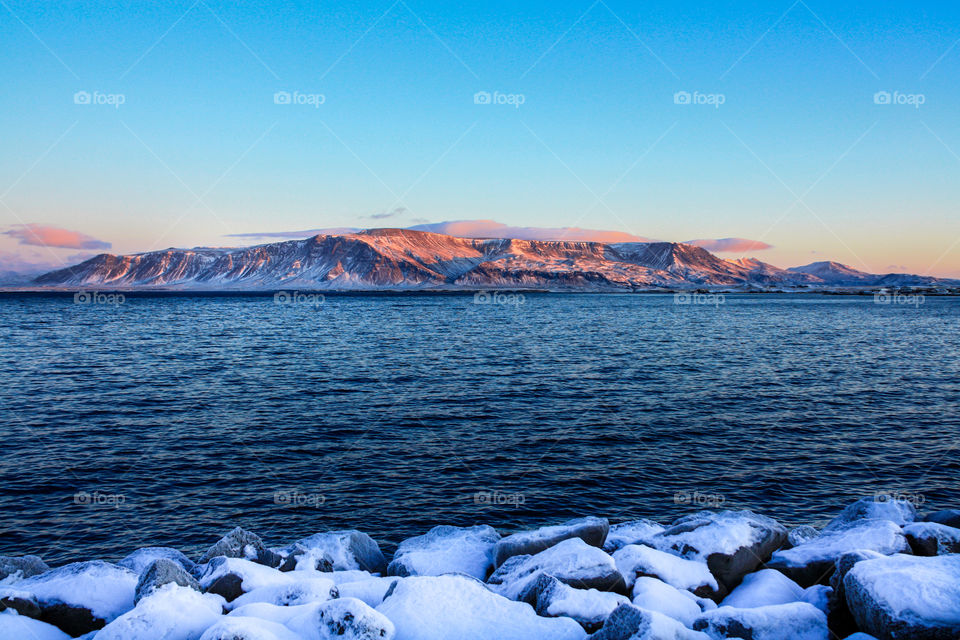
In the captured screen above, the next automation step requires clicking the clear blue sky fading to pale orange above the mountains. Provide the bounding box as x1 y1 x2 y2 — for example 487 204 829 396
0 0 960 277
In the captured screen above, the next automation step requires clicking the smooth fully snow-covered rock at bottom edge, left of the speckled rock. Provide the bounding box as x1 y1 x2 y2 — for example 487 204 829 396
96 584 224 640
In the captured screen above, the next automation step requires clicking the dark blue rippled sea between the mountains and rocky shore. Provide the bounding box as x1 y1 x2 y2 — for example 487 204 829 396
0 293 960 562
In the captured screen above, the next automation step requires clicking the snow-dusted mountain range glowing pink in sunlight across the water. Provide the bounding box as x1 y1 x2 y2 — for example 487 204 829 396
34 229 952 291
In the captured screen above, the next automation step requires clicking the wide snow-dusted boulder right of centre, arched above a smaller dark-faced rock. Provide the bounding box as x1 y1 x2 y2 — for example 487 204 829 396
487 538 627 600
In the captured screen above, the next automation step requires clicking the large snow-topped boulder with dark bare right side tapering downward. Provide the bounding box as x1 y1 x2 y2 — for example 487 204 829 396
653 511 787 597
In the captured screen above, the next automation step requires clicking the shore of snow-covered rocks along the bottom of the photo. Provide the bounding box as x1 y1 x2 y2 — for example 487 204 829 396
0 496 960 640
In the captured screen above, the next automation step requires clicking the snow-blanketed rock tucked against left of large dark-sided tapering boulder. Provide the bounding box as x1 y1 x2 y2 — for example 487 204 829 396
613 544 719 598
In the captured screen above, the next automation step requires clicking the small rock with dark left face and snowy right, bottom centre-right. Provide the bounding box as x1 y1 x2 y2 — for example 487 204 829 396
520 574 630 632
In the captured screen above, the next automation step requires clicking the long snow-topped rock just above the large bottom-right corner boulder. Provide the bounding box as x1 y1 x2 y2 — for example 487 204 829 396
767 519 910 587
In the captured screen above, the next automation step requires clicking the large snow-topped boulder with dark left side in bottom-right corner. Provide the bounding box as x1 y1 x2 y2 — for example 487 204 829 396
843 555 960 640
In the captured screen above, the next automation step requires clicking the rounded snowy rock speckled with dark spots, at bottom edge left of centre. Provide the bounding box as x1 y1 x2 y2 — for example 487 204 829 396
286 598 396 640
